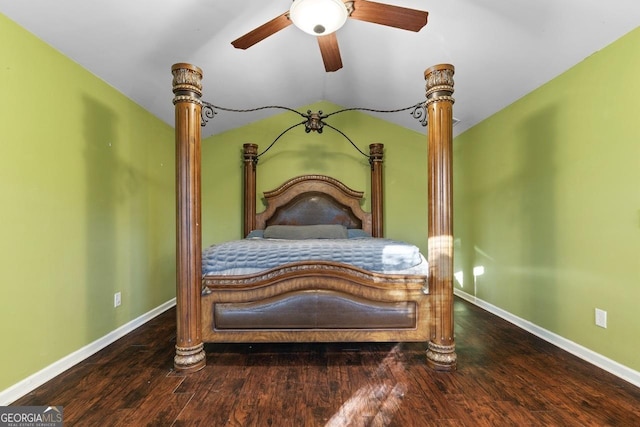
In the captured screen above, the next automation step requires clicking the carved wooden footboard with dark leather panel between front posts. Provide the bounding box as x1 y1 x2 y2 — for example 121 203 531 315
202 262 430 342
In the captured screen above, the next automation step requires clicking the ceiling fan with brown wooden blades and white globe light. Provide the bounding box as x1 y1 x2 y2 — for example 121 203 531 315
231 0 428 72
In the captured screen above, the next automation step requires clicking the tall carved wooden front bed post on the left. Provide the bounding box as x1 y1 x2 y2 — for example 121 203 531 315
171 63 206 372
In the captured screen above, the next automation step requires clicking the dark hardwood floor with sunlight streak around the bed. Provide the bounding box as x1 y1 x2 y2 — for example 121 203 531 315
14 299 640 427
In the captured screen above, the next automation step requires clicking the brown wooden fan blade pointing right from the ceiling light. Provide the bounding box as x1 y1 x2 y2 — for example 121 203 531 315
349 0 429 32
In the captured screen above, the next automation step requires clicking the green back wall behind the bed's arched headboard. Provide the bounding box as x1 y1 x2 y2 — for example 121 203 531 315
202 101 427 254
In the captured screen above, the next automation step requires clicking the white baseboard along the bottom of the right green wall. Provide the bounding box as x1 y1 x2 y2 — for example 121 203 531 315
453 289 640 387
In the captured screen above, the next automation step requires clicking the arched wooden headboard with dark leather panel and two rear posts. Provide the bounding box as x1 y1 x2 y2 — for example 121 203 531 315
244 144 383 237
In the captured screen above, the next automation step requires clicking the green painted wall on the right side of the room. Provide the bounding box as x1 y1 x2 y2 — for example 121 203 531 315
454 29 640 370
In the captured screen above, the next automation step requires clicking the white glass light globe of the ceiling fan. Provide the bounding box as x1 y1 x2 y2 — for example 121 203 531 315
289 0 349 36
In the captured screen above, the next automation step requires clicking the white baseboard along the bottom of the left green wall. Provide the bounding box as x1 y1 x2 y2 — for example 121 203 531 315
0 298 176 406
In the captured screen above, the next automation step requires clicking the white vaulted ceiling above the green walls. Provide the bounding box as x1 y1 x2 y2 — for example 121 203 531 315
0 0 640 136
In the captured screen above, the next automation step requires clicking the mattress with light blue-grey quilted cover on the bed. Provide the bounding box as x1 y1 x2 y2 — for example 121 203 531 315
202 238 428 275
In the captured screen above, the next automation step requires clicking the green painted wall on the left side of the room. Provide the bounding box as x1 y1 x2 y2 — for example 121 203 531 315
0 15 175 390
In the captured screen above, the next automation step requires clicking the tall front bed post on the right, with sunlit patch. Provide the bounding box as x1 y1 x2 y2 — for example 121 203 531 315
424 64 457 371
